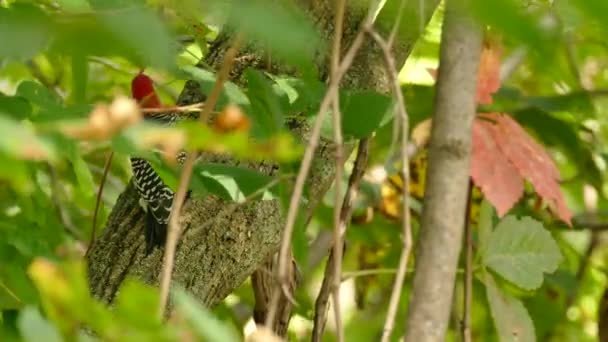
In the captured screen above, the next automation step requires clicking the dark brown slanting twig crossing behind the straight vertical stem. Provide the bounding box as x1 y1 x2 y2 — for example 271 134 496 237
312 138 370 341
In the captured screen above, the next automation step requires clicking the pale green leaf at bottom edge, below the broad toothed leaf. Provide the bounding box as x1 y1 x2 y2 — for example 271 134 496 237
484 273 536 341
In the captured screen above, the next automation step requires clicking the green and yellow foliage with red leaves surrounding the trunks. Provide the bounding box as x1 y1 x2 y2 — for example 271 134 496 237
0 0 608 341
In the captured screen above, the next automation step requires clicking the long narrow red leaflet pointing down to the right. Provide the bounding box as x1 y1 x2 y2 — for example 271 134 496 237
477 113 572 224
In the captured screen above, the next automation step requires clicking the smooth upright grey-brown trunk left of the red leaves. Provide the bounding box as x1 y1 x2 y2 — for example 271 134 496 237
405 0 482 342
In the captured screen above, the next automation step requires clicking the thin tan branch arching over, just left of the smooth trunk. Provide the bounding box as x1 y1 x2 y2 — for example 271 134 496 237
368 29 412 342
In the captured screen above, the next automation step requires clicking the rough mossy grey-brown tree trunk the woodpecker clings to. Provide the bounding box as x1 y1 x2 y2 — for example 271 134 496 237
88 0 438 328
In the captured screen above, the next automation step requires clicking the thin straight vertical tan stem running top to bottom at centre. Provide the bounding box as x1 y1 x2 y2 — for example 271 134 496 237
328 0 345 342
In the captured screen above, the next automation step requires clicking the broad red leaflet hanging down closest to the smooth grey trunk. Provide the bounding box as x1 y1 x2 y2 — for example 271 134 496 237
471 119 524 216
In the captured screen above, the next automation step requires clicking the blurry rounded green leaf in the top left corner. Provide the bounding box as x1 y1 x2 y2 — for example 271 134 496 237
0 3 54 60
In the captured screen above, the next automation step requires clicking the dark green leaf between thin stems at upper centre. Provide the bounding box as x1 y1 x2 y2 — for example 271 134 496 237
340 91 392 139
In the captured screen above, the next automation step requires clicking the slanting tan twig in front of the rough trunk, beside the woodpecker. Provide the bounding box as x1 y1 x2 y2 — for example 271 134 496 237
158 34 243 317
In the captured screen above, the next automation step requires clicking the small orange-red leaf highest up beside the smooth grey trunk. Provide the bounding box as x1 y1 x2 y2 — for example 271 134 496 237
476 45 500 105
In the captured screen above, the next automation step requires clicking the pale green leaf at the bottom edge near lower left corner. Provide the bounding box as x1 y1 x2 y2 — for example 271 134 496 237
18 306 63 342
